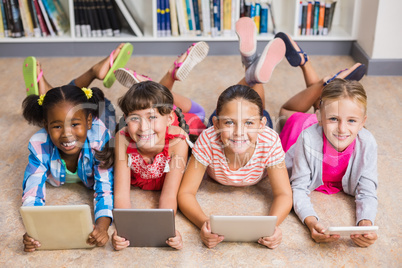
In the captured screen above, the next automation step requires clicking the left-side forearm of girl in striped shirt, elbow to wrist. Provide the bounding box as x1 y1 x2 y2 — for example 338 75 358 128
178 193 209 229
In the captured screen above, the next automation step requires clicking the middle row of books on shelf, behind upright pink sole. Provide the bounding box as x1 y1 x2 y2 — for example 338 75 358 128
157 0 274 37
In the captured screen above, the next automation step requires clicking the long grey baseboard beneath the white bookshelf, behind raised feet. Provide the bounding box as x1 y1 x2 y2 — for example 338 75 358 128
0 40 353 57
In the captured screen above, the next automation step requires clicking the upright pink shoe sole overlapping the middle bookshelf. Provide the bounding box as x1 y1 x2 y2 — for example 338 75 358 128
236 17 257 57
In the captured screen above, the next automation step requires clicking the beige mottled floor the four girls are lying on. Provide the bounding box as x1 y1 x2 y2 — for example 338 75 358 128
0 53 402 267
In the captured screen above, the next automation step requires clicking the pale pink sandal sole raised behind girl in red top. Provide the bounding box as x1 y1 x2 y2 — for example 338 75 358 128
175 42 209 81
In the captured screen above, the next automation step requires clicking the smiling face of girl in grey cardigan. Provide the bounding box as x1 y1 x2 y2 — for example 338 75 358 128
317 97 367 152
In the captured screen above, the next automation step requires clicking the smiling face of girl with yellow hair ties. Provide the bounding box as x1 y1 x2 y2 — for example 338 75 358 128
45 102 92 159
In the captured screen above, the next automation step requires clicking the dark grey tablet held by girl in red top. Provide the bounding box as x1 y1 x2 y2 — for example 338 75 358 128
113 208 176 247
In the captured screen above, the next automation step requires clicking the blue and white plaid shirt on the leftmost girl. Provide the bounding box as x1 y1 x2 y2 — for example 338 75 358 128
22 120 113 221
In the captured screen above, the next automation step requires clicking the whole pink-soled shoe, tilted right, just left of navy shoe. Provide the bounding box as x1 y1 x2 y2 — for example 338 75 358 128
246 38 286 86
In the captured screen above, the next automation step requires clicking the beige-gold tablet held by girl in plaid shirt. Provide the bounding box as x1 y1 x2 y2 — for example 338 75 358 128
20 205 94 250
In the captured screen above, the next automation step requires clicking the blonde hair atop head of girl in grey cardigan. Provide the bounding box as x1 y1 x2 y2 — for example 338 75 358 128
320 78 367 114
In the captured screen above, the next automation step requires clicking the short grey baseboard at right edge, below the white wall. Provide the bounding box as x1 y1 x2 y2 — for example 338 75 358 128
351 42 402 76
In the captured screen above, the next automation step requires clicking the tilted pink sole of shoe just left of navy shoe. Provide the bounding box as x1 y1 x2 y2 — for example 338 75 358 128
254 38 286 84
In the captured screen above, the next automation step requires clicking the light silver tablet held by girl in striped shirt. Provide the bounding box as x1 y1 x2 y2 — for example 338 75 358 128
210 215 277 242
